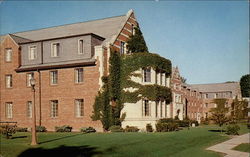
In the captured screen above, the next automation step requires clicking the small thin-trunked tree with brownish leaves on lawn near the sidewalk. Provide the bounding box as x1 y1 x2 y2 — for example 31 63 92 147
210 99 229 131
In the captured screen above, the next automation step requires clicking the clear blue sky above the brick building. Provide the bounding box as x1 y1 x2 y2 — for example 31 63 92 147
0 0 249 84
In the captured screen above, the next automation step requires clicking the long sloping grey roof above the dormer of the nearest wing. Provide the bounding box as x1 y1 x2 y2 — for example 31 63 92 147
13 15 127 46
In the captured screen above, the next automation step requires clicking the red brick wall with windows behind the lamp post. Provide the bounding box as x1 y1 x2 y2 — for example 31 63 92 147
0 38 102 131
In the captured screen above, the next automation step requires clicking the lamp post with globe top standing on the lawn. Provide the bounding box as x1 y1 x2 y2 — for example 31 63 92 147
30 78 37 145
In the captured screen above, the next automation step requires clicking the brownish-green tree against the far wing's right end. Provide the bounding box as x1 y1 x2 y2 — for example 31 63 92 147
231 97 248 120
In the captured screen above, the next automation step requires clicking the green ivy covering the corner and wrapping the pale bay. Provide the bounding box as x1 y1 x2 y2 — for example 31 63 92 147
92 51 172 130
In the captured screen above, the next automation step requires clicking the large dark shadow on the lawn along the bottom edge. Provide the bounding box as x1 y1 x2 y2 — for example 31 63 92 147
18 145 102 157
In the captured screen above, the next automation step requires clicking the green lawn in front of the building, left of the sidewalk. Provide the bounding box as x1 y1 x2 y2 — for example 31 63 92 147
0 126 248 157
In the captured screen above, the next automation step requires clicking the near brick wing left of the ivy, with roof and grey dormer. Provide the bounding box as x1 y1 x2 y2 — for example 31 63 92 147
0 10 138 131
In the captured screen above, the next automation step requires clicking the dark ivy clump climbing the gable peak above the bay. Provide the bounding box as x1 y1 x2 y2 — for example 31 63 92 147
127 27 148 53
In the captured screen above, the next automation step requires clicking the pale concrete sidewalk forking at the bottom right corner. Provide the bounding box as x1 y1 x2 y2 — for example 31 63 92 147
207 133 250 157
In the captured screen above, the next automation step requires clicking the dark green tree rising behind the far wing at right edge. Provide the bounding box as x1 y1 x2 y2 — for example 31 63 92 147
240 74 250 97
